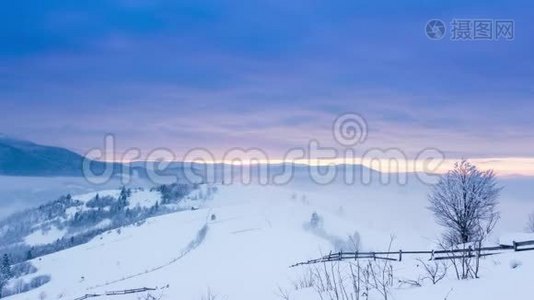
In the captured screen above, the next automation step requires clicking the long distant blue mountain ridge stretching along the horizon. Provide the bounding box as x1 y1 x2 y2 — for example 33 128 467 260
0 134 380 183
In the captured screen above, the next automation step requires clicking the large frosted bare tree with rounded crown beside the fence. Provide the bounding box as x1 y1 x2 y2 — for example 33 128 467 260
429 160 501 279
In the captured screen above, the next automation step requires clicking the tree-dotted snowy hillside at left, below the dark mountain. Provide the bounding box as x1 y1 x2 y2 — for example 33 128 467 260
0 184 214 263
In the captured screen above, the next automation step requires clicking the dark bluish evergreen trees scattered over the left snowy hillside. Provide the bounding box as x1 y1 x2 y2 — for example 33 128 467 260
0 184 202 263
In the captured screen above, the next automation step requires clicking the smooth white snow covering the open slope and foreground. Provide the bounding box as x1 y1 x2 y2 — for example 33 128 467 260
4 176 534 300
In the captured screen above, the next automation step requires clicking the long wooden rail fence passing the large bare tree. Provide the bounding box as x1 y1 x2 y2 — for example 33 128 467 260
290 241 534 268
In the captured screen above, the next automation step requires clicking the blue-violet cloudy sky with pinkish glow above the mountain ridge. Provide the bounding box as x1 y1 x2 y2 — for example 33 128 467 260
0 0 534 174
